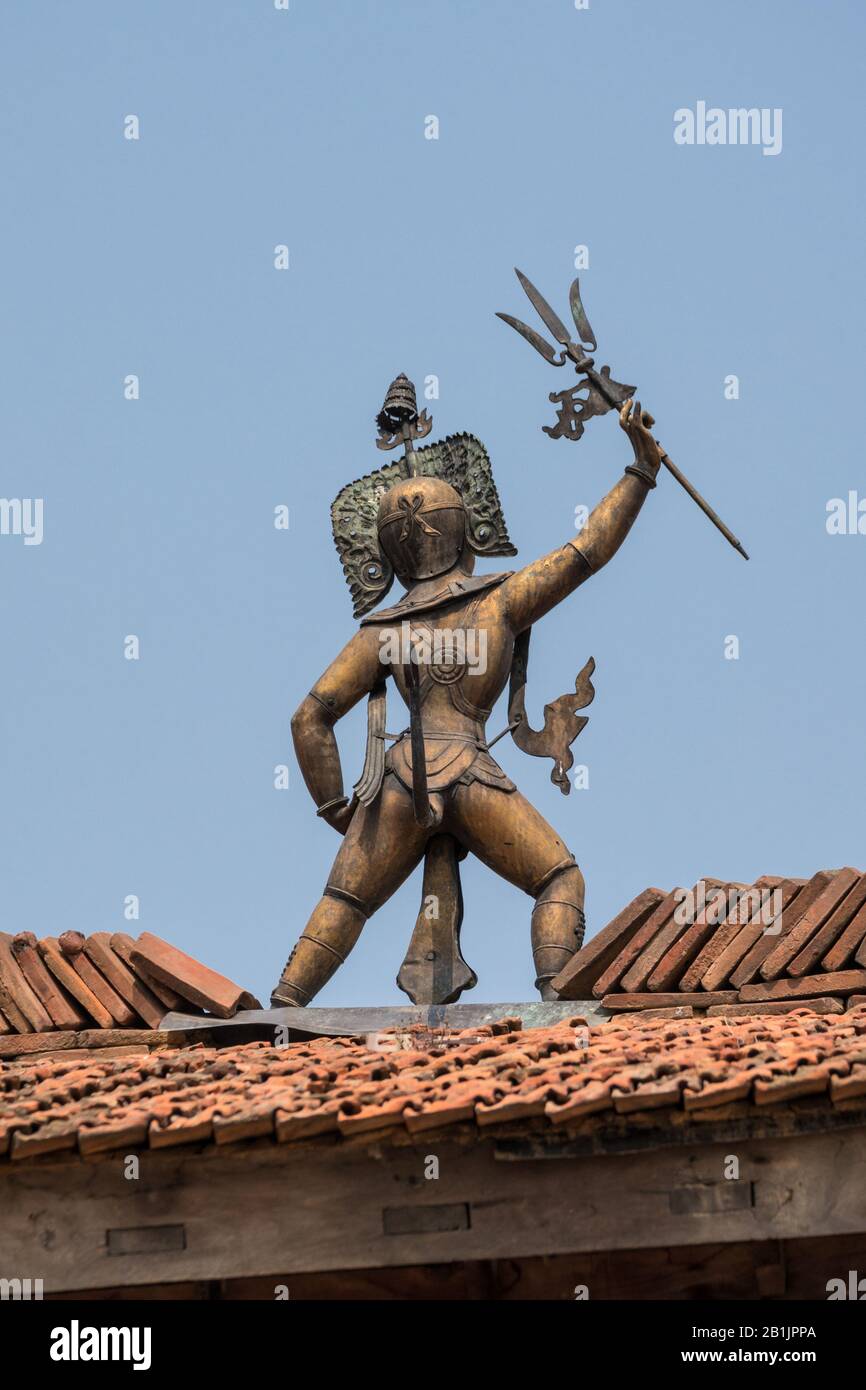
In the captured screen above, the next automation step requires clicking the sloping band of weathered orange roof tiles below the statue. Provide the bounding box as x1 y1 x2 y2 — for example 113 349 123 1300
0 1006 866 1161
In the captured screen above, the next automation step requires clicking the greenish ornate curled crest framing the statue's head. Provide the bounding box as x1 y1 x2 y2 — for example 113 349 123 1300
331 434 517 617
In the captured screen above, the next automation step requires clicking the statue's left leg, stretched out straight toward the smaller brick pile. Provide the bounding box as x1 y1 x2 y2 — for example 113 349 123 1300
271 774 430 1008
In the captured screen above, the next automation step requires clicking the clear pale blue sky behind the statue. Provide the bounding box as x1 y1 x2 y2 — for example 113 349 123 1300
0 0 866 1004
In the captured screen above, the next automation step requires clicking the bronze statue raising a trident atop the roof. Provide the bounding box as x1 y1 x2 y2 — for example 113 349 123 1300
272 277 738 1005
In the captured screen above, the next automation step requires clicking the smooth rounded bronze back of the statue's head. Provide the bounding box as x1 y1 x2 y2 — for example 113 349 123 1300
377 477 466 584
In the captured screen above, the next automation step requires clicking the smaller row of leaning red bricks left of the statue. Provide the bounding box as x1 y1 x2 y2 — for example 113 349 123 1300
0 931 260 1037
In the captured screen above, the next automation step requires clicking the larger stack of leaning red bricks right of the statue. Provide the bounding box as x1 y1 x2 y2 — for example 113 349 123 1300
553 869 866 1012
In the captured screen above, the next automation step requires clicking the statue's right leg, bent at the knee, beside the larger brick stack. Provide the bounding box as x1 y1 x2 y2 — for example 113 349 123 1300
443 781 585 999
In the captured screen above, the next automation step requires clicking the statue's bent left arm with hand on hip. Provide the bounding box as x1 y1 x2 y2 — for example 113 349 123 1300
292 627 388 828
